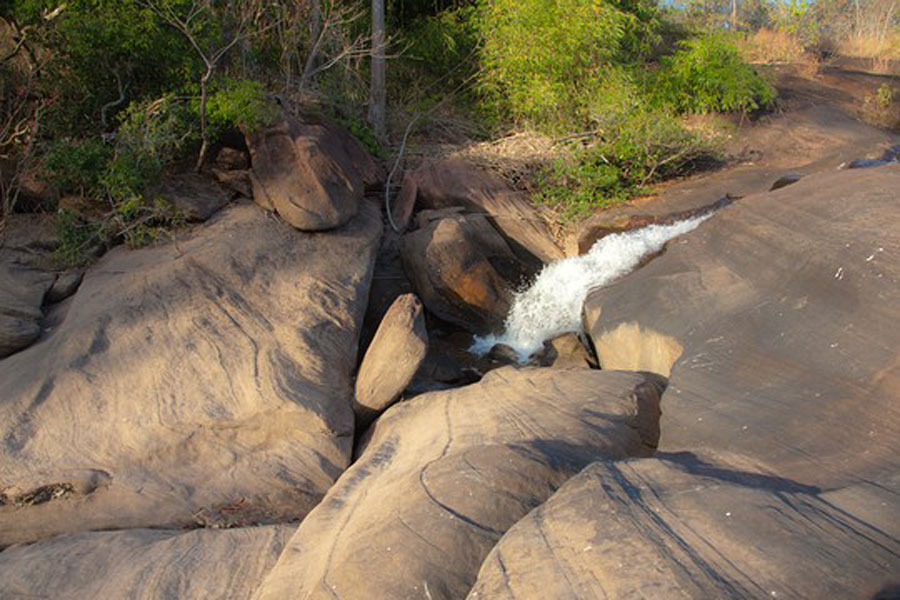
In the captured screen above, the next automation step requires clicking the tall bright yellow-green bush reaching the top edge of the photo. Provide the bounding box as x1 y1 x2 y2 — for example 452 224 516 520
477 0 657 132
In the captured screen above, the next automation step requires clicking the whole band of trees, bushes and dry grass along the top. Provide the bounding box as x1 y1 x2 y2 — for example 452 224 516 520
0 0 900 247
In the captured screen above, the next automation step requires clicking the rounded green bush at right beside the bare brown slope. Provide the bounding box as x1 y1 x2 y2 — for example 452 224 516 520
650 34 775 113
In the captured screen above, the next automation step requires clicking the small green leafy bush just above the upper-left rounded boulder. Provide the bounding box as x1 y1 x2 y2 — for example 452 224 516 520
206 79 278 133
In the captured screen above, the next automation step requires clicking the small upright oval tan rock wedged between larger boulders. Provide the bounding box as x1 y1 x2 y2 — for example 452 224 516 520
353 294 428 428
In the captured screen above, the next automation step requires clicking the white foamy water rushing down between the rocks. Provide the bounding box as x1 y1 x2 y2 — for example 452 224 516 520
469 214 711 362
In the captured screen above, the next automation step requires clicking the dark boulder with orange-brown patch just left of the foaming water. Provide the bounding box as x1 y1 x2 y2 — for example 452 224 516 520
400 215 525 333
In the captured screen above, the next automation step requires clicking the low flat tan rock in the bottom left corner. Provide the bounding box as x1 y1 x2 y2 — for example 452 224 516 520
0 525 296 600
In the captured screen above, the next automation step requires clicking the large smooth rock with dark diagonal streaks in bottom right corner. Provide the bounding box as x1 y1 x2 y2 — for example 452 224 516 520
468 453 900 600
